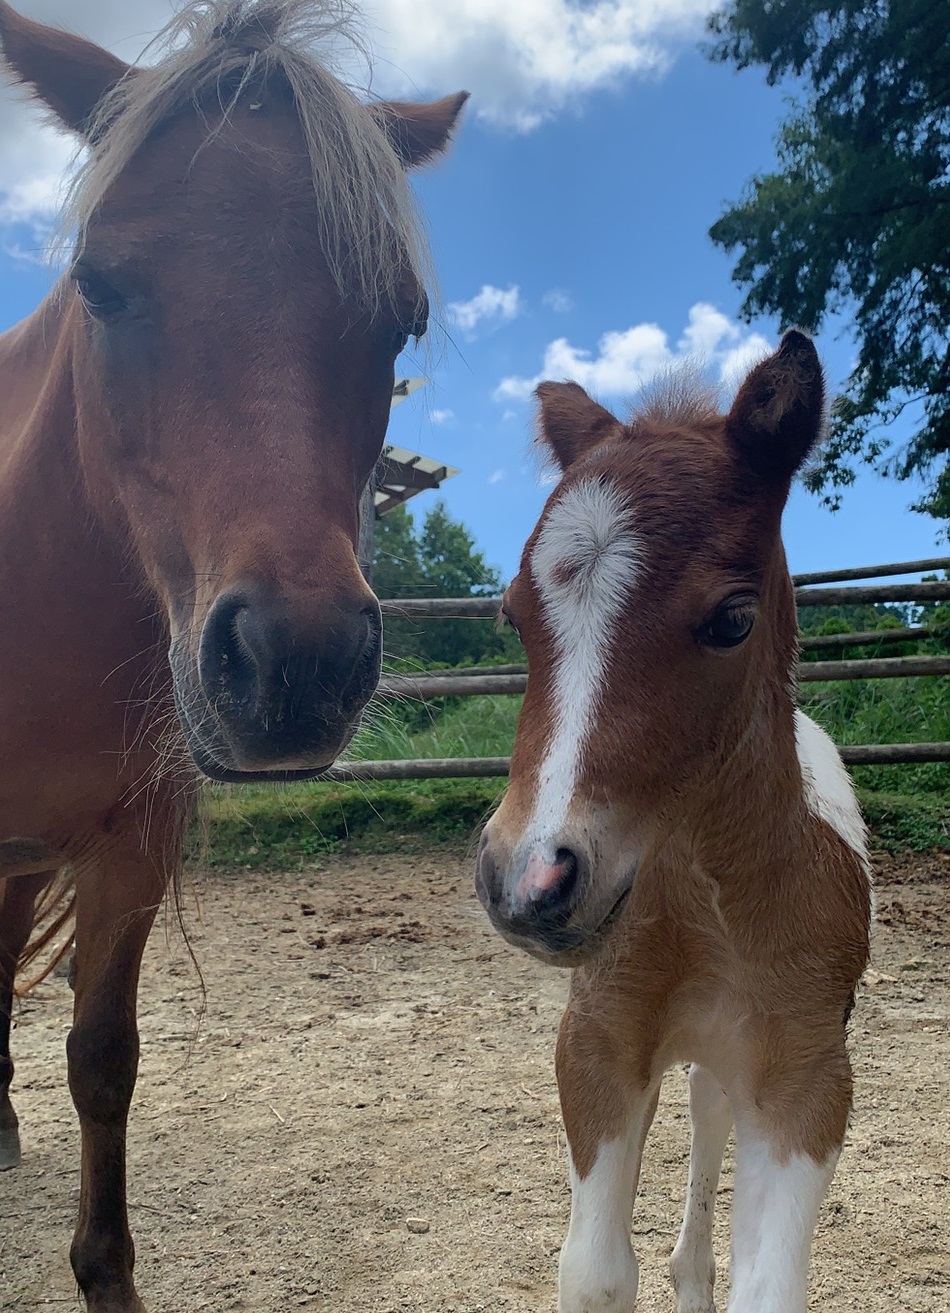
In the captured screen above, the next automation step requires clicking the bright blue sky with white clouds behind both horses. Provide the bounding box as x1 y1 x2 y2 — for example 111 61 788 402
0 0 945 576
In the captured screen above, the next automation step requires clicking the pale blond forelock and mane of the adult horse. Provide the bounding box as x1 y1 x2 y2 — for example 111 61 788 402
64 0 429 307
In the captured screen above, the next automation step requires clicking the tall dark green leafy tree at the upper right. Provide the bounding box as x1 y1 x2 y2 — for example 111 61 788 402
709 0 950 520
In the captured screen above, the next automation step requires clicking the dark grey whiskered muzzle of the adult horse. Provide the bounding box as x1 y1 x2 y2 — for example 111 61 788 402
171 587 382 781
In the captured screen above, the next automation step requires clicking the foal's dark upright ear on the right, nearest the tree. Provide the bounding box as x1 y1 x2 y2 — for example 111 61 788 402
726 328 824 483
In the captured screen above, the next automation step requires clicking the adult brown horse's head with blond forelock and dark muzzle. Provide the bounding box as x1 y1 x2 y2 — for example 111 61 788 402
0 0 466 780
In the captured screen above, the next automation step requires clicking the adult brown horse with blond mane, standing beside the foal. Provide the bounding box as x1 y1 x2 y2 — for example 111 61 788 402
0 0 466 1313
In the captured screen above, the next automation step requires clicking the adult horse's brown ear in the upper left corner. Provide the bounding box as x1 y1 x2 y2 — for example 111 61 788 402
0 0 129 135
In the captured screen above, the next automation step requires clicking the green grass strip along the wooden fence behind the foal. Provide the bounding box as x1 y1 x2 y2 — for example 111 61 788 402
194 678 950 869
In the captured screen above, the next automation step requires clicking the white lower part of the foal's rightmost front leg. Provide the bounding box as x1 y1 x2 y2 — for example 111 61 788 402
728 1130 838 1313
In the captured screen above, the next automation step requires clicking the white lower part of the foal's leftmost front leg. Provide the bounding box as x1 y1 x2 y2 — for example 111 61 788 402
558 1092 656 1313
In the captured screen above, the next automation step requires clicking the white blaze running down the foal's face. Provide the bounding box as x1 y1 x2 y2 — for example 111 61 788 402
525 478 643 860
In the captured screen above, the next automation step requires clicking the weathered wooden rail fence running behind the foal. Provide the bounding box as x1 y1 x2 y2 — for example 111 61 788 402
324 557 950 780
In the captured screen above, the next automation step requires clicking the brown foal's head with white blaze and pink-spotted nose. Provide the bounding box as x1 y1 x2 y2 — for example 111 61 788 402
478 332 823 965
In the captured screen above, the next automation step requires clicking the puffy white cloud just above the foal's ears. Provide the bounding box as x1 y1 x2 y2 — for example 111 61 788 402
495 301 769 402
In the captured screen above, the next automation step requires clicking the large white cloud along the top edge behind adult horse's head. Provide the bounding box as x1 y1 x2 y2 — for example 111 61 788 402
0 0 710 233
